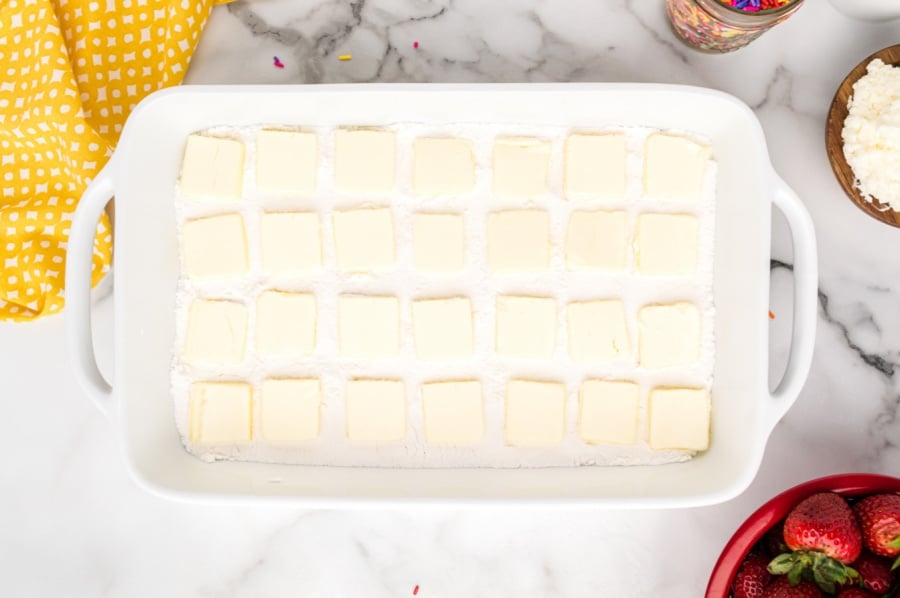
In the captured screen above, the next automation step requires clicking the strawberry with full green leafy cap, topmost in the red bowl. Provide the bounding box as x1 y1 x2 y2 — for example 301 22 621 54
769 492 862 594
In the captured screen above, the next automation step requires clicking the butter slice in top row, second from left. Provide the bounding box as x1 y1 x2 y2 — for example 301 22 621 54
256 129 319 196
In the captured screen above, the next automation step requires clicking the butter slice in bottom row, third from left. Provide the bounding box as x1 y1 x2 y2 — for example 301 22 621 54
346 379 406 444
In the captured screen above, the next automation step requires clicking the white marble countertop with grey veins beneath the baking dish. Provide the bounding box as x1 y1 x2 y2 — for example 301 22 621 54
0 0 900 598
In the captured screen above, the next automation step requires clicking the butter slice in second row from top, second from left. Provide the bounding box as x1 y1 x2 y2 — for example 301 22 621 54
260 212 322 274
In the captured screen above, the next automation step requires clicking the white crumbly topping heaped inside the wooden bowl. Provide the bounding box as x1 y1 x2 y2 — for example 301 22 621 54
841 58 900 210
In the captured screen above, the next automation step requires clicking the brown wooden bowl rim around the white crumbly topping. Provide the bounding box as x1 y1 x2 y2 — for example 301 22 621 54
825 45 900 227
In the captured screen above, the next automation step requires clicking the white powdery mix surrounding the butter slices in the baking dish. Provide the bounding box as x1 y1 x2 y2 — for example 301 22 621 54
172 123 716 467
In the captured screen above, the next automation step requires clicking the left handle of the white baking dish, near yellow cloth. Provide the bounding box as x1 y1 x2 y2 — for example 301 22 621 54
63 159 113 416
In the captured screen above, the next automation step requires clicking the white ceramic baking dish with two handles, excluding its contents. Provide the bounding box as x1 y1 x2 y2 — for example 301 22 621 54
66 84 817 507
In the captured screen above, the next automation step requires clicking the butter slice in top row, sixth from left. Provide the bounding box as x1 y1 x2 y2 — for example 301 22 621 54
565 133 628 199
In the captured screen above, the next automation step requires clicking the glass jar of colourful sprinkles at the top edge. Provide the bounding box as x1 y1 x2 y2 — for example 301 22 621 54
666 0 803 53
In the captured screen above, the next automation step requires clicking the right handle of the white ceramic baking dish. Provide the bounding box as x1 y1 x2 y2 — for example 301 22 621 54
767 172 819 429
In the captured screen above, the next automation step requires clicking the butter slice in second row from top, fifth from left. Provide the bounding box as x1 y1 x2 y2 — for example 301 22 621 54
487 210 550 274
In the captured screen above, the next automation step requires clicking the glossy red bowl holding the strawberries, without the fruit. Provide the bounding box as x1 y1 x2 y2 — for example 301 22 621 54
706 473 900 598
